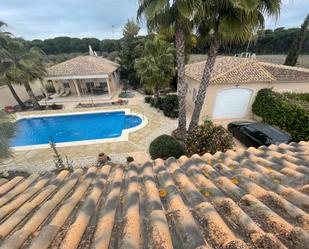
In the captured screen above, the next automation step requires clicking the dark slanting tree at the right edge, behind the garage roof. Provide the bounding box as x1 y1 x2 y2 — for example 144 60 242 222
284 15 309 66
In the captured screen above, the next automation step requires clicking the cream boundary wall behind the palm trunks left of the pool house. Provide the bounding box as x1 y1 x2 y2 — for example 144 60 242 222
0 80 42 109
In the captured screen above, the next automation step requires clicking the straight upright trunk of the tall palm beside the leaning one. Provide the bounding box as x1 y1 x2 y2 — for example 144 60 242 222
175 23 187 140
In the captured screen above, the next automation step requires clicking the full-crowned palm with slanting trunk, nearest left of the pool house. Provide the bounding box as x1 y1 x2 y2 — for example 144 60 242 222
1 39 46 109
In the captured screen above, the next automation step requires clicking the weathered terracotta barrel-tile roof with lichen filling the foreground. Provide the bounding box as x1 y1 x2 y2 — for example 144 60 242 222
0 142 309 249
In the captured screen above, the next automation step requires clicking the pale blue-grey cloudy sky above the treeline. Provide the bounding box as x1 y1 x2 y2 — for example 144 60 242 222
0 0 309 40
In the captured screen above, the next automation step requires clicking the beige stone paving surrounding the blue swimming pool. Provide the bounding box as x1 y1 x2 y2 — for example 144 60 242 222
1 93 177 172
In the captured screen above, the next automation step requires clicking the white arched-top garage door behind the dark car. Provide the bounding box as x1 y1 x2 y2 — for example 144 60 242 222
212 88 252 119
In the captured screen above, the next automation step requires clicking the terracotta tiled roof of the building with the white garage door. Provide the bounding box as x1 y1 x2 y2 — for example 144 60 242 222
186 56 309 84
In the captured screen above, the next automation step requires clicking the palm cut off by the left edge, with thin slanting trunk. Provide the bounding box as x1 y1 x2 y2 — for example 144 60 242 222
0 21 26 110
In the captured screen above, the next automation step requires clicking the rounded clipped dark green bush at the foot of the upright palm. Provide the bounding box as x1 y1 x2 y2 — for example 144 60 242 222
149 135 186 159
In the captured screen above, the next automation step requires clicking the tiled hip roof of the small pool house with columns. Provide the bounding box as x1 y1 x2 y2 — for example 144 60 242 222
47 55 119 77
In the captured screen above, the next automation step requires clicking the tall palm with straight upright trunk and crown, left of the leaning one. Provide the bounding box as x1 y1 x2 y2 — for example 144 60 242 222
137 0 201 139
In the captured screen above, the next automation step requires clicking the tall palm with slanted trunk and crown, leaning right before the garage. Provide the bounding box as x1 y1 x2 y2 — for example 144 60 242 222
189 0 281 131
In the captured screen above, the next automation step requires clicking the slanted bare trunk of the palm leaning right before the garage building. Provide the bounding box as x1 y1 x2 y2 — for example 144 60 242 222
189 38 220 131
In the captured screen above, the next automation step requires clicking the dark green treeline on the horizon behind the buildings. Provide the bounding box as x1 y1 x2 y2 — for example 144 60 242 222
17 27 309 55
